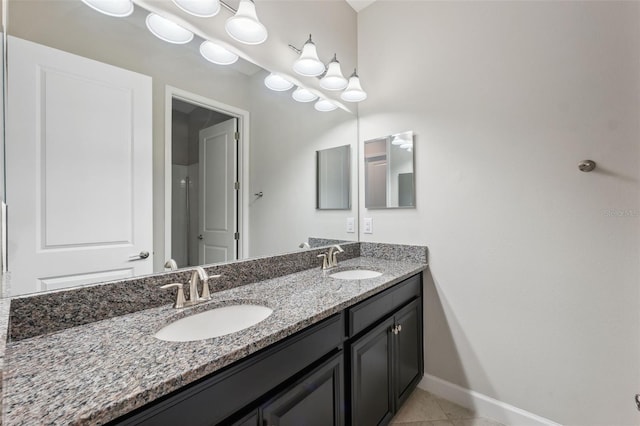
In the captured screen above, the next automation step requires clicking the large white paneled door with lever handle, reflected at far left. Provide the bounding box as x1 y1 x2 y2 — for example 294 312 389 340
6 37 153 295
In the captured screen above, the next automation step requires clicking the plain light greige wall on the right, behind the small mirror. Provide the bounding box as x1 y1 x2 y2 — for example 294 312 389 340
358 1 640 425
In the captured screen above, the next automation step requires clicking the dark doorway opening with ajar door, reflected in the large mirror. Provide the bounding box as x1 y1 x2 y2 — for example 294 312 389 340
171 98 239 268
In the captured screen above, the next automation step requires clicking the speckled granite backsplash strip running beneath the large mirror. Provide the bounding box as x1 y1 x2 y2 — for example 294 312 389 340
9 243 360 340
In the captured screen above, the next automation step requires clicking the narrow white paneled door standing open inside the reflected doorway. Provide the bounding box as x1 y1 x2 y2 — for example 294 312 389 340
198 118 238 264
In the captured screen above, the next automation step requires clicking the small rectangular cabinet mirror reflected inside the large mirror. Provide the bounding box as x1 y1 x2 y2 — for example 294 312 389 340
316 145 351 210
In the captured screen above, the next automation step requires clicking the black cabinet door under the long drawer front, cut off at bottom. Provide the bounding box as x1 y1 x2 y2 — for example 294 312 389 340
262 351 344 426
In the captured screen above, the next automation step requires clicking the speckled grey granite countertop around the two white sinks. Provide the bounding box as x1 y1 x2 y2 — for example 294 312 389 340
3 257 426 425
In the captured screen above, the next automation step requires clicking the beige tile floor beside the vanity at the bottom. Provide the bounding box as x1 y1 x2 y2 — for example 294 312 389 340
391 388 504 426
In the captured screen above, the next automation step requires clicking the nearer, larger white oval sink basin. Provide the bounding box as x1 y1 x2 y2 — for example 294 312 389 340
154 305 273 342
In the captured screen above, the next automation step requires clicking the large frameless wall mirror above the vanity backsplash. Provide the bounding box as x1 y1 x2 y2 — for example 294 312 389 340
3 0 358 296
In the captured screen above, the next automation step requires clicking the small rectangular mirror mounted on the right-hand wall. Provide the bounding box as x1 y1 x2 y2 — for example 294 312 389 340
364 131 416 209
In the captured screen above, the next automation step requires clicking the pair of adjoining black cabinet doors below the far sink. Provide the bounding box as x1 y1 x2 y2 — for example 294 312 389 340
349 298 424 426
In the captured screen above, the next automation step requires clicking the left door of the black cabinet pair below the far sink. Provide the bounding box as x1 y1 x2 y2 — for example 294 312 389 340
350 318 394 426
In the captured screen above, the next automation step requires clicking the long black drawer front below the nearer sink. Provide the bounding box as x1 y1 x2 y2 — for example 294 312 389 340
114 314 344 426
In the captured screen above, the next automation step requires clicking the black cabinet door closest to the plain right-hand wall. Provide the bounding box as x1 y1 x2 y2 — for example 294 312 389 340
394 299 424 409
